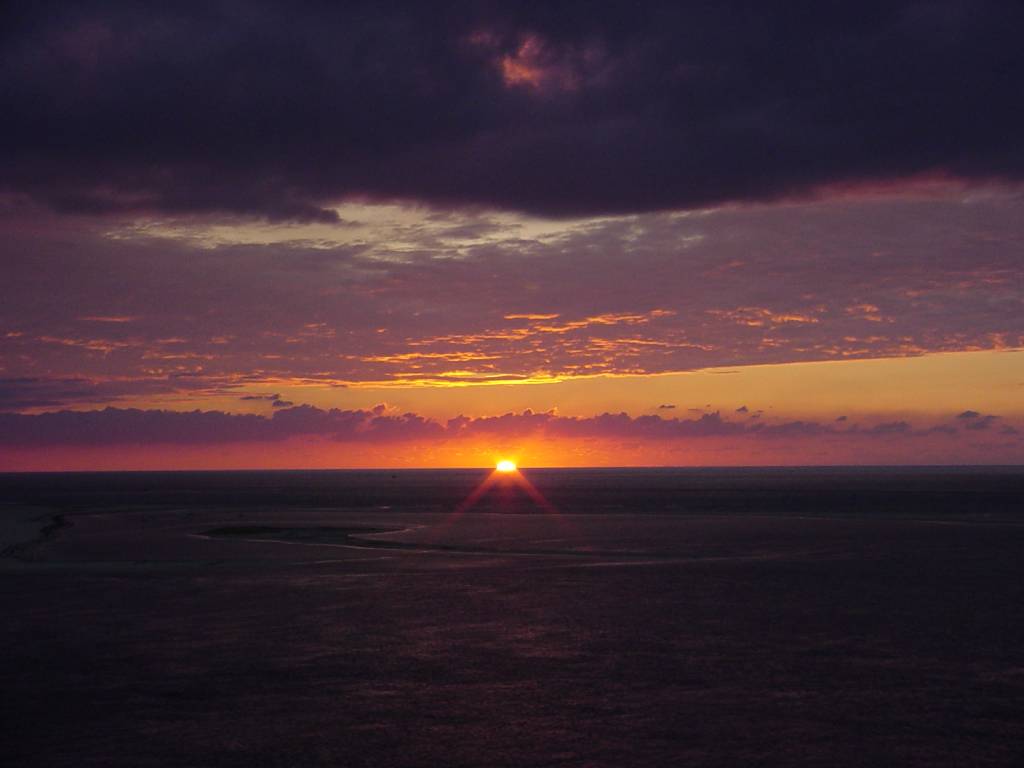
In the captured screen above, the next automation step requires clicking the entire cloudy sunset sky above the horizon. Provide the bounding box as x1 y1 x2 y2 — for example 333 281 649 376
0 0 1024 470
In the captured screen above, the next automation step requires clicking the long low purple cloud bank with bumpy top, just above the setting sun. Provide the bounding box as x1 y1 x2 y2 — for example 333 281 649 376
0 406 1016 447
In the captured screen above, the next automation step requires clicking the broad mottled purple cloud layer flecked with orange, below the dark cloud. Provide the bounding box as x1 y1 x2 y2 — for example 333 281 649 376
8 189 1024 399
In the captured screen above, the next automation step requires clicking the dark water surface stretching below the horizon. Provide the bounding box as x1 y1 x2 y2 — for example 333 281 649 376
0 469 1024 767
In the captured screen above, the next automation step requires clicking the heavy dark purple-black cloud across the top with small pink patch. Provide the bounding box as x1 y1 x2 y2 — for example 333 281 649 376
0 0 1024 221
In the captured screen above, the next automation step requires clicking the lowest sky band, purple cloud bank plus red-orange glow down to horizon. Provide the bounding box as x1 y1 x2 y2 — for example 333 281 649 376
0 404 1024 469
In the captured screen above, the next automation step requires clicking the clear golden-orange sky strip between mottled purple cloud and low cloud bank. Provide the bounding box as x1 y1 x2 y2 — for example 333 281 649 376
49 349 1024 423
